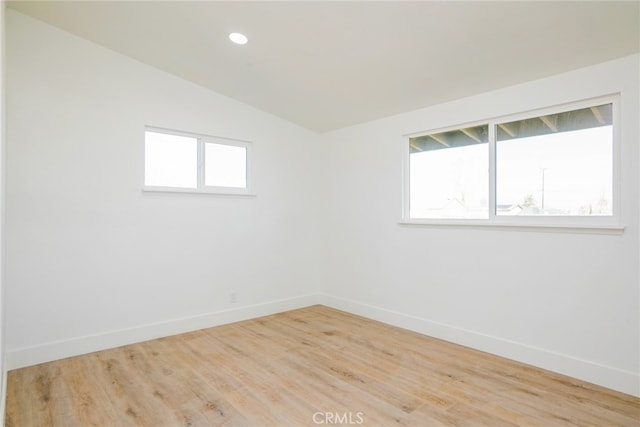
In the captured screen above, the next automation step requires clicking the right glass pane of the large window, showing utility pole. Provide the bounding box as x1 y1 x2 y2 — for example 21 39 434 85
496 104 613 216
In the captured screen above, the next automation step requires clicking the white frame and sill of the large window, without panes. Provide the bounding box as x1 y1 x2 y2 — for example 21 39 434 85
400 94 625 234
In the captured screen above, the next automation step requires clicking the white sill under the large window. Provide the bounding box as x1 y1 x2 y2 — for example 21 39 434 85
398 219 625 235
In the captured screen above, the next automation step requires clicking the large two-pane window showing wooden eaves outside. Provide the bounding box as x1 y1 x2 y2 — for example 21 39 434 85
405 98 619 231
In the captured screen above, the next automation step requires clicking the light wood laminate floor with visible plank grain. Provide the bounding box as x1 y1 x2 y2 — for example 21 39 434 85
6 306 640 427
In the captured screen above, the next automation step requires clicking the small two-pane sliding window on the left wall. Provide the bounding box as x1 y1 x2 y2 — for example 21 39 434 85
144 128 251 194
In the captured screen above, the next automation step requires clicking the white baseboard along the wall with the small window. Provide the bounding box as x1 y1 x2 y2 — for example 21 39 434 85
5 294 318 370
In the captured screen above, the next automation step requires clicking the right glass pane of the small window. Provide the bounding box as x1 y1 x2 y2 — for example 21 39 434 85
204 143 247 188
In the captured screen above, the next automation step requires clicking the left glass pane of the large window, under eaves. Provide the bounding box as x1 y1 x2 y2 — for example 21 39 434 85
409 125 489 218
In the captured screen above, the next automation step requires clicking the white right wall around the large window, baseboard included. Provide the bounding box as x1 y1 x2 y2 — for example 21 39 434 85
324 55 640 394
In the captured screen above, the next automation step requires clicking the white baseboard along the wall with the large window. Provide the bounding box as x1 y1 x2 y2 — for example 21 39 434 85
317 294 640 397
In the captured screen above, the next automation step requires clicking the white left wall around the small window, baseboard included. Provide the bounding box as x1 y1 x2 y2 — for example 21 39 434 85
7 10 319 367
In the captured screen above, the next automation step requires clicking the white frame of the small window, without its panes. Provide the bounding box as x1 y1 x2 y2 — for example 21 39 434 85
142 126 255 196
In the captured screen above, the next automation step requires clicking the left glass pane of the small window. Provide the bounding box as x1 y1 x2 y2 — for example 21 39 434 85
144 131 198 188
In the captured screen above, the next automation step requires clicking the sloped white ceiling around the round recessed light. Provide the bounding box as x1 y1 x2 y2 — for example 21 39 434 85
8 1 640 132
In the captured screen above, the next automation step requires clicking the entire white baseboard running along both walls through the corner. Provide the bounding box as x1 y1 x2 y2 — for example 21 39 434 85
5 294 640 397
